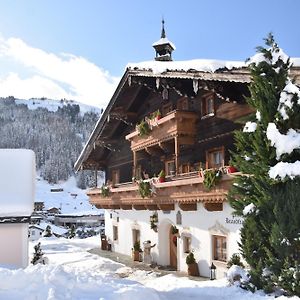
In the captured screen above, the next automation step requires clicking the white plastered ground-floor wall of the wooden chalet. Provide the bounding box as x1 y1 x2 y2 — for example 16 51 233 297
105 203 241 278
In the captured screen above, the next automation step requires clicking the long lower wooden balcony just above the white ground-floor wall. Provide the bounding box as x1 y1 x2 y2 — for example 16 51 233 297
88 172 237 211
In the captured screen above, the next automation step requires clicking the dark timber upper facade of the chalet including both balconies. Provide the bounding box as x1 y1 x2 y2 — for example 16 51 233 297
75 63 262 210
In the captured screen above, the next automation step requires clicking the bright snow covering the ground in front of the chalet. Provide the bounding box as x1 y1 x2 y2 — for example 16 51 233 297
0 237 299 300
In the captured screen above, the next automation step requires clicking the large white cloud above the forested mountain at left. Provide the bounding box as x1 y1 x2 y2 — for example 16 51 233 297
0 38 119 107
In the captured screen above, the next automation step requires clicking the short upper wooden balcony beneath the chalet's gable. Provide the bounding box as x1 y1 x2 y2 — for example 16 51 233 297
126 110 197 152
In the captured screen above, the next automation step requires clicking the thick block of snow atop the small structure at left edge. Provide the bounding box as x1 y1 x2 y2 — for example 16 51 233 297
0 149 35 217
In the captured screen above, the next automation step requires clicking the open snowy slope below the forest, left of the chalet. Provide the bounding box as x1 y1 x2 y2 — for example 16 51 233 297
35 177 102 215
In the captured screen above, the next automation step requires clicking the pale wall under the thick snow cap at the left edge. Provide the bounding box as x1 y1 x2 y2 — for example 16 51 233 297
0 223 28 268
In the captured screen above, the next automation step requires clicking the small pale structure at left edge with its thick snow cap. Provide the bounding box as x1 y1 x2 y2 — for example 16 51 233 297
0 149 35 268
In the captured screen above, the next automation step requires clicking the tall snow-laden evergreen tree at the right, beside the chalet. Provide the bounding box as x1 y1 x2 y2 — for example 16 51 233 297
228 34 300 295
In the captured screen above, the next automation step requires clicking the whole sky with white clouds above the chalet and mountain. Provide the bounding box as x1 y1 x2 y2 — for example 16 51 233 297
0 0 300 106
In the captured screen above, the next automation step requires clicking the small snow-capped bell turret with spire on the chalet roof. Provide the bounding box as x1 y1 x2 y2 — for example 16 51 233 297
152 19 176 61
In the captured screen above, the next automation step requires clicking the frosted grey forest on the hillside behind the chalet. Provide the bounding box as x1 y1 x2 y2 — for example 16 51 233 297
0 97 99 188
